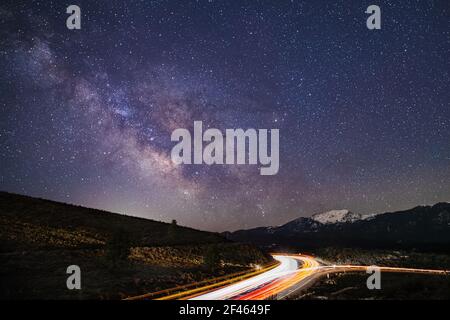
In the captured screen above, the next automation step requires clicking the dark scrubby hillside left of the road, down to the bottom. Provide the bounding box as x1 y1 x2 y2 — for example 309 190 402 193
0 192 271 299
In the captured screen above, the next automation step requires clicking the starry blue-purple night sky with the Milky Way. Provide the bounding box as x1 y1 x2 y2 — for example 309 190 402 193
0 0 450 231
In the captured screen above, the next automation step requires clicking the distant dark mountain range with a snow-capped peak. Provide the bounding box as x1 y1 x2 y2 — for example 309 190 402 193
224 203 450 251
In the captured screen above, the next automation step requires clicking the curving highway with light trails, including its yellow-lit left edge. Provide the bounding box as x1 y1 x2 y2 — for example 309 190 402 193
128 254 450 300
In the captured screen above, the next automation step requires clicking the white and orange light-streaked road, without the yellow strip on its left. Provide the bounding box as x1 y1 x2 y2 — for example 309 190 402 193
185 255 450 300
